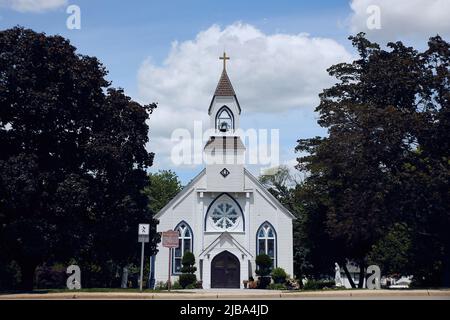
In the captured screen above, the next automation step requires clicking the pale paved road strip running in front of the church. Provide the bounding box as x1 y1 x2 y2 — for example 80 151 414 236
0 289 450 300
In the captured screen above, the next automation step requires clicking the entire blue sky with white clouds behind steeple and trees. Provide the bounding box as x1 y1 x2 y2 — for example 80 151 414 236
0 0 450 183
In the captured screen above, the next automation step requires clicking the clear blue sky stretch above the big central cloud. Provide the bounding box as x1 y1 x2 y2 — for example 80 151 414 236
0 0 350 96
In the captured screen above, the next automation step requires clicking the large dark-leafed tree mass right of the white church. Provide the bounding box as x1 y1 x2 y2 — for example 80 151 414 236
296 34 449 284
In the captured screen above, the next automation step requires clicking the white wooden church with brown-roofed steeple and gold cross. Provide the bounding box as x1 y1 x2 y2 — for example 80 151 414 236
152 53 295 289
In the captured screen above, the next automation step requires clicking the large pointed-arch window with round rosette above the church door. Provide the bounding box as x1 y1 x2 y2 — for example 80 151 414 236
205 193 244 232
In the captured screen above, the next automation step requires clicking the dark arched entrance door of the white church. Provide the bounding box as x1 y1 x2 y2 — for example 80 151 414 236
211 251 241 288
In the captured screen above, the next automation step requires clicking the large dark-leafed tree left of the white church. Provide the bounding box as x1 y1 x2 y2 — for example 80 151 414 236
0 27 156 289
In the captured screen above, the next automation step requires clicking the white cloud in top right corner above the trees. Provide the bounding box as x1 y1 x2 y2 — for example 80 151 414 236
350 0 450 41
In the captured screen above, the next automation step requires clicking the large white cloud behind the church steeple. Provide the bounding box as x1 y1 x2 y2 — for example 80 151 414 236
138 23 352 170
